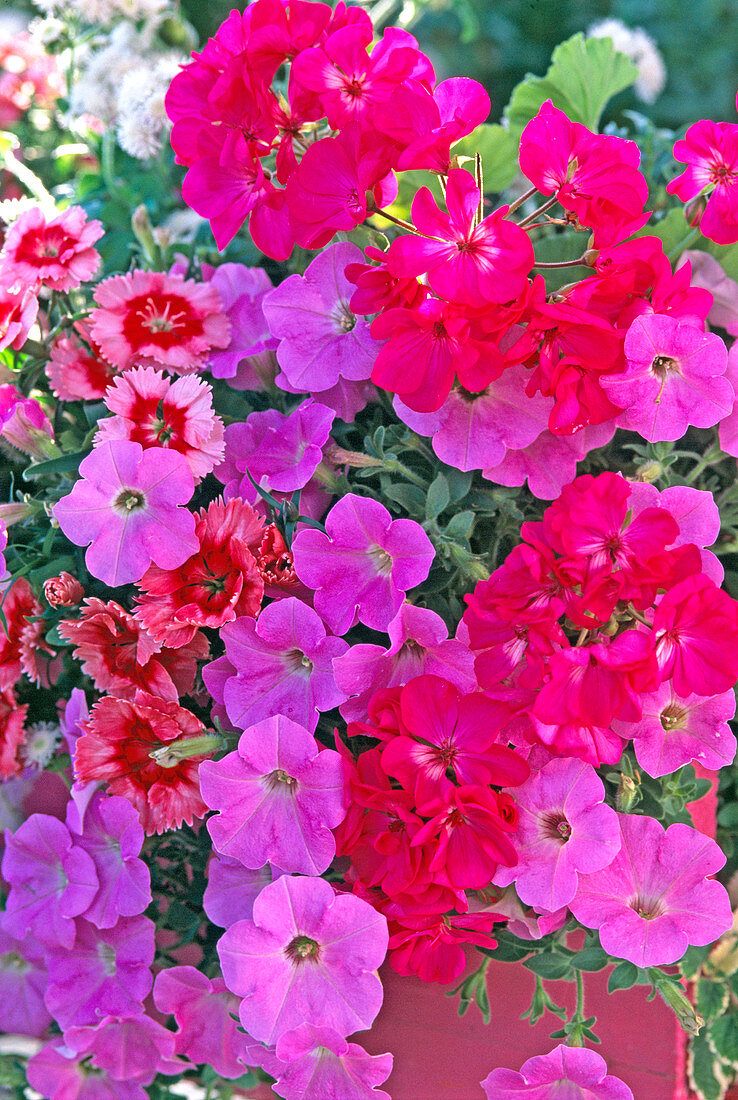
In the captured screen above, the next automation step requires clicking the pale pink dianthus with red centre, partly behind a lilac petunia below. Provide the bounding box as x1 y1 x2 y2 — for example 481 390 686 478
93 366 225 482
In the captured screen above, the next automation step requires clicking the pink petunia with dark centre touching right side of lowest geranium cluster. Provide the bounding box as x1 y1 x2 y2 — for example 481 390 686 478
495 758 620 913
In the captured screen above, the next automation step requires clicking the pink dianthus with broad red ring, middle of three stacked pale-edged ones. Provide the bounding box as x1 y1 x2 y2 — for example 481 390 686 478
90 271 231 374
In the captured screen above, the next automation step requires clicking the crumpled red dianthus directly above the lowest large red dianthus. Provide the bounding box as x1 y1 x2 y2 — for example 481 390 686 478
58 596 209 702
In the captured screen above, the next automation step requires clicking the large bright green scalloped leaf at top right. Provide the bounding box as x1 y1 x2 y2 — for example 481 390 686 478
505 34 638 139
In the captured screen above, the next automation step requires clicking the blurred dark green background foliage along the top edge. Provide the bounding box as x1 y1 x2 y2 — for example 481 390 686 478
181 0 738 129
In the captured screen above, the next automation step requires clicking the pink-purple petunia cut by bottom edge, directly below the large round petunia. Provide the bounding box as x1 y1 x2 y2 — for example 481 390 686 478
262 1024 393 1100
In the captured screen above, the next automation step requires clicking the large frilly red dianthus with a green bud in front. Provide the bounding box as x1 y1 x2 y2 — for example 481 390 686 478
75 691 208 836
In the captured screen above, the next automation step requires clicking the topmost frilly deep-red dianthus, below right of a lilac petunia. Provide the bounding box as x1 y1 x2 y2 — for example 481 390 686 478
135 497 264 648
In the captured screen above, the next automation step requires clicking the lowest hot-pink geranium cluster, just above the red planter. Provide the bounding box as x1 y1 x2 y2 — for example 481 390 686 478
337 675 529 981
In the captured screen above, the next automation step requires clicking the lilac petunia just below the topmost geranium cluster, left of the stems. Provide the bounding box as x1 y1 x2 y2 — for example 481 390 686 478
263 243 379 393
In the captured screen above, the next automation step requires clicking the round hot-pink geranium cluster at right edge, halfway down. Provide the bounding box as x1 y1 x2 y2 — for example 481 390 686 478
464 473 738 773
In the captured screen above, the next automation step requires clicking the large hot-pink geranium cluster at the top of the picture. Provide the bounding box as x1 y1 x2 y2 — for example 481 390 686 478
166 0 489 260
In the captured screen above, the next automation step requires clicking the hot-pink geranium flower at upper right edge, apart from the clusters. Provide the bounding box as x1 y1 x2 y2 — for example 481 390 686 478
667 119 738 244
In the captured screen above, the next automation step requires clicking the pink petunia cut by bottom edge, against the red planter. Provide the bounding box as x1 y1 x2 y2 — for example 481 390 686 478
482 1045 634 1100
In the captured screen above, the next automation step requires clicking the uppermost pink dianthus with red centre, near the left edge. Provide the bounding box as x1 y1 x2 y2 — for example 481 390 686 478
0 207 104 290
